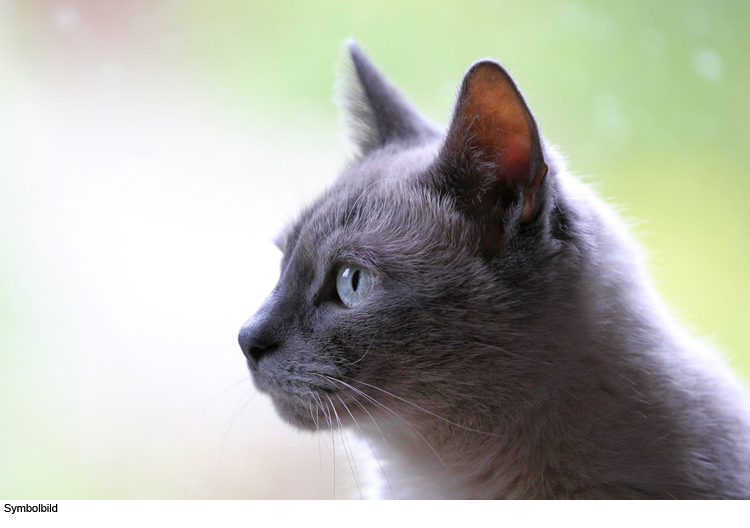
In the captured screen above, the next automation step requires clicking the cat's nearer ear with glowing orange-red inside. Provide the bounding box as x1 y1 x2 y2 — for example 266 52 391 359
438 60 547 245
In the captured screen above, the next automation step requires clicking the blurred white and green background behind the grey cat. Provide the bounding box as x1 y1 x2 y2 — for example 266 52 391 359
0 0 750 499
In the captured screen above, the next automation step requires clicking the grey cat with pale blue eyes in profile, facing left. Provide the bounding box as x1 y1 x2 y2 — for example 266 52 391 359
239 42 750 499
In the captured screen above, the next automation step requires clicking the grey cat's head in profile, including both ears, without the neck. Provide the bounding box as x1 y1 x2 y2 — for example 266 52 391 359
239 43 559 434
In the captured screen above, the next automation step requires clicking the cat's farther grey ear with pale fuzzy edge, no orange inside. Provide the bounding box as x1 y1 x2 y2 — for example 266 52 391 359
340 40 440 154
